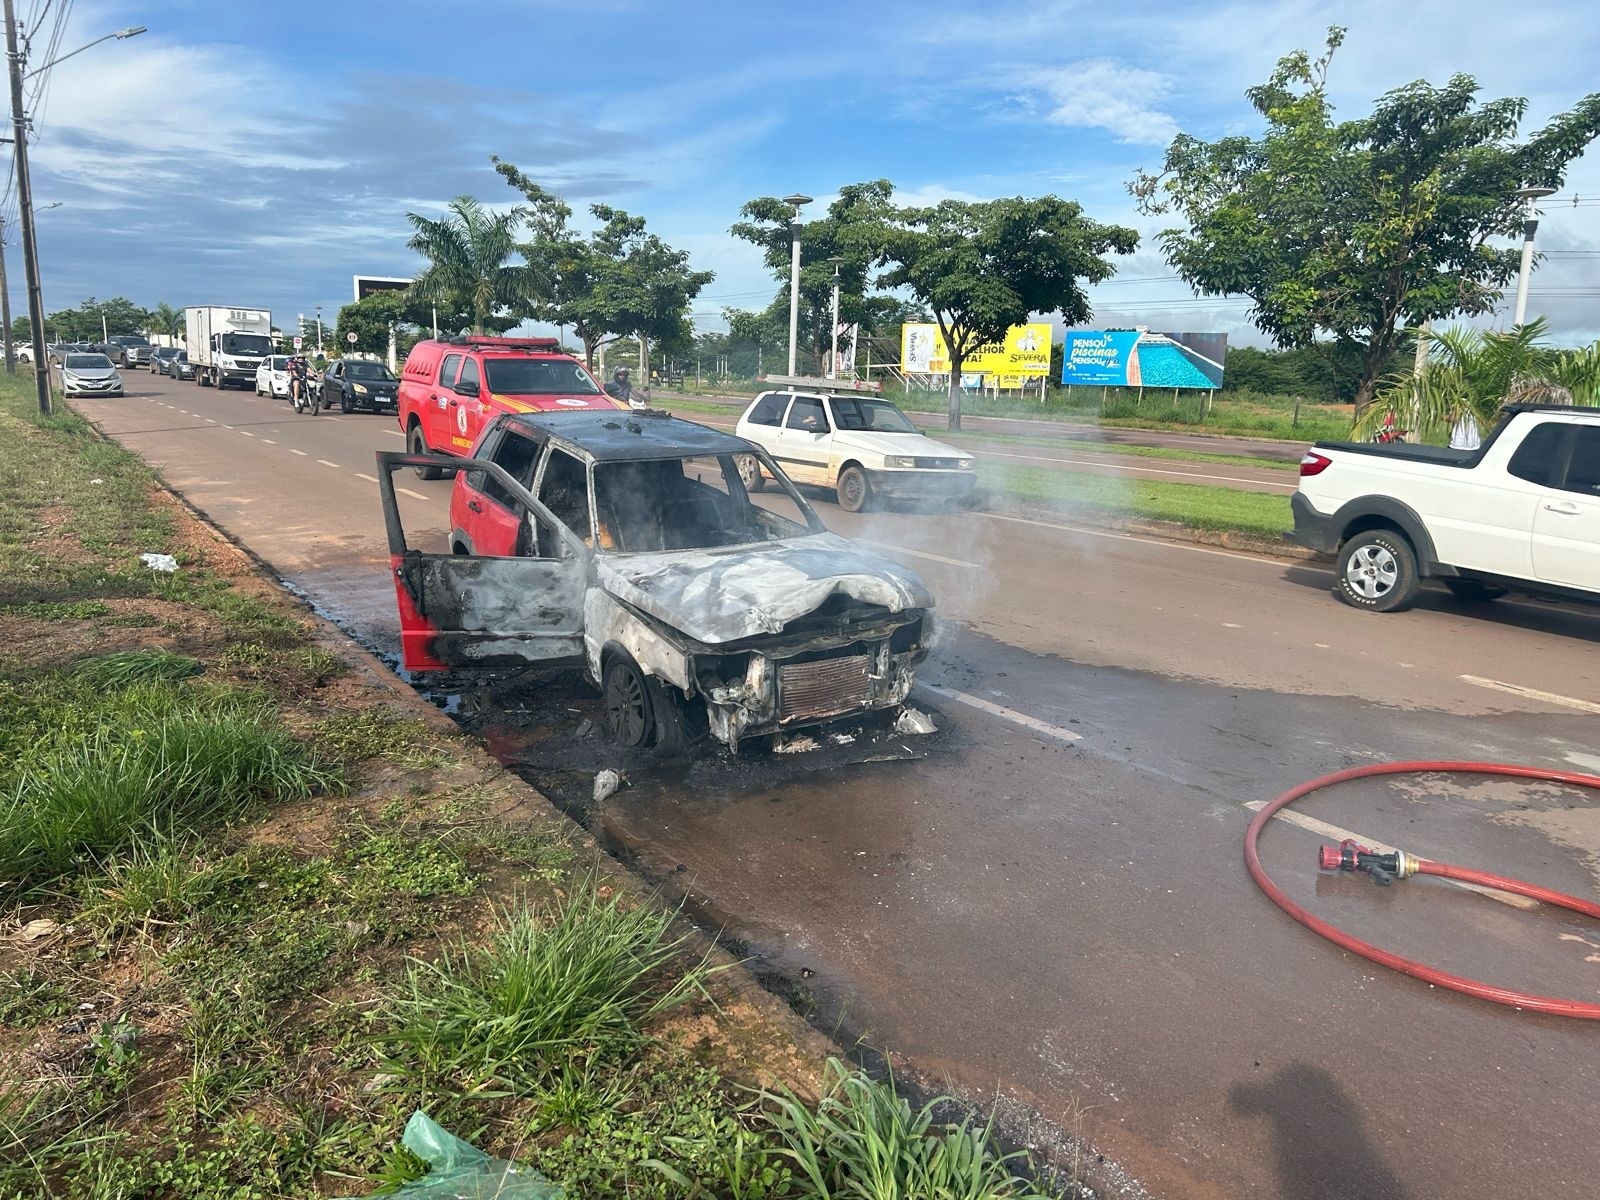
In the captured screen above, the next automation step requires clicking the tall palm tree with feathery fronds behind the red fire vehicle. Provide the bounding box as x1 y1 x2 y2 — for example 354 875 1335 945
405 195 526 333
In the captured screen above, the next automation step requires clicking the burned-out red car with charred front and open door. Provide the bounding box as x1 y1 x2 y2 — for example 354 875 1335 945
378 411 934 754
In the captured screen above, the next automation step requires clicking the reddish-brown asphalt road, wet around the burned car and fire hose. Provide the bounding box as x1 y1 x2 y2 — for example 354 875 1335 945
82 376 1600 1200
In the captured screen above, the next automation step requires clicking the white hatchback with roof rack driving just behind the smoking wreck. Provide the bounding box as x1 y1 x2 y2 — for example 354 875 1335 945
738 389 974 512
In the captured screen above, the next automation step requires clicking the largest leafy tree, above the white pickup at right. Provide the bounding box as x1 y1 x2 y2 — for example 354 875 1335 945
1130 26 1600 411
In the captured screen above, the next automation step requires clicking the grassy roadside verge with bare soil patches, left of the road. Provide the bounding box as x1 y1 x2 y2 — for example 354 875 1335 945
0 381 1066 1200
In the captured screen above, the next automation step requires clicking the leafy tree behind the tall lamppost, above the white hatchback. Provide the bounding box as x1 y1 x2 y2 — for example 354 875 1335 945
730 179 899 374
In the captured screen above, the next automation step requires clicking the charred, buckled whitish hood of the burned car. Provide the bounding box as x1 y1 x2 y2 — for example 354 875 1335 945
595 533 933 643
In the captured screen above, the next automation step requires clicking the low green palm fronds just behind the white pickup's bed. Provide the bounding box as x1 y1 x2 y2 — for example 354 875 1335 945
1350 318 1600 438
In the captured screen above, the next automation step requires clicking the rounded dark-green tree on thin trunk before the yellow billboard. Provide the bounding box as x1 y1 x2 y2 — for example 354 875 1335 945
861 195 1139 430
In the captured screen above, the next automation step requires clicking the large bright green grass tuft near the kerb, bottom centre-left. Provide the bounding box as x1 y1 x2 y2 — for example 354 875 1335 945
382 878 710 1088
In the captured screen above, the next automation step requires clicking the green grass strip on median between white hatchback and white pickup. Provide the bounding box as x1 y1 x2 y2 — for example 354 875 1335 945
978 462 1294 541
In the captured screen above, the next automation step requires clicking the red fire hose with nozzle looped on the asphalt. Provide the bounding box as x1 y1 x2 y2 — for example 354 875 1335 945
1245 762 1600 1021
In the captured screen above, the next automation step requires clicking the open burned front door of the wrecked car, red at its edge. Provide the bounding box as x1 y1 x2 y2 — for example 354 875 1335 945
378 451 590 670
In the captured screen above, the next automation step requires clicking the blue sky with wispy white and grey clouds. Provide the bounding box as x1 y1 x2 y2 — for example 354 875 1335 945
18 0 1600 341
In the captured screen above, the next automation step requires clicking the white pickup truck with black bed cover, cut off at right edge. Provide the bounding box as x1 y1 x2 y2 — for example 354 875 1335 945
1285 405 1600 613
